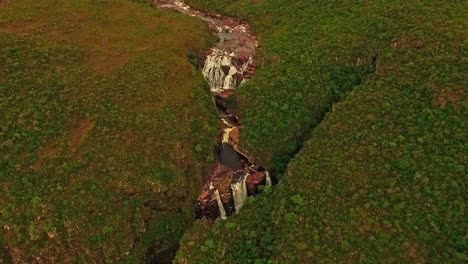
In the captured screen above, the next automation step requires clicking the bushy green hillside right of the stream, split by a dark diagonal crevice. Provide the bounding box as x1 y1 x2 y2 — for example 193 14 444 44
177 0 468 263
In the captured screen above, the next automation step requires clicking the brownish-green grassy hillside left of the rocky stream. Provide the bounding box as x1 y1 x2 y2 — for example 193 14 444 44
0 0 217 263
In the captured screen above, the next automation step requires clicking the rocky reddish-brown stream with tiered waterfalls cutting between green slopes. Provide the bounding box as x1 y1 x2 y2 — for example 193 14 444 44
154 0 272 220
